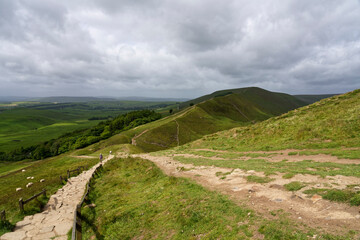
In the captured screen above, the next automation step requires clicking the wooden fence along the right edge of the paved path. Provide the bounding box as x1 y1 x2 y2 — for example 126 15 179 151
71 164 102 240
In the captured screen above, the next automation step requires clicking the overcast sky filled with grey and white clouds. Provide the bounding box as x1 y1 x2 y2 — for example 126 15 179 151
0 0 360 98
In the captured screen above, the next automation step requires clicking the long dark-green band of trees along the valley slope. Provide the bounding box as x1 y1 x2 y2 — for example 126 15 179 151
0 110 161 161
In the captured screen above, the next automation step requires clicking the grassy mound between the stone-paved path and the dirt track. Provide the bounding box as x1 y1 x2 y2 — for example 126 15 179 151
82 158 351 239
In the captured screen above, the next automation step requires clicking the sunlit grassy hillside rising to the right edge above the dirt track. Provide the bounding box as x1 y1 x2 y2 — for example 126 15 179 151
186 90 360 151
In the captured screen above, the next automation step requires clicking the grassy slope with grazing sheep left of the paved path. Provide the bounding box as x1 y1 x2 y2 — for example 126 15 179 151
0 152 98 234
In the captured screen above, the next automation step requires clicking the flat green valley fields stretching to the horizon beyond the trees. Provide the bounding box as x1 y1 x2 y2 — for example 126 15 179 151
0 101 174 152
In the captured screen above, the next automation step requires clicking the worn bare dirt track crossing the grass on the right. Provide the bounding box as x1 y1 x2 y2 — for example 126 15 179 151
136 154 360 234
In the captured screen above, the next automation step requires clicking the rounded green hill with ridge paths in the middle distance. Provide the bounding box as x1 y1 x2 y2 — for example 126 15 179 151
94 88 305 152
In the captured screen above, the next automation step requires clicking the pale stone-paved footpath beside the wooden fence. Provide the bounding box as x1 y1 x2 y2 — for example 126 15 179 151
0 155 114 240
